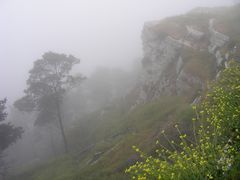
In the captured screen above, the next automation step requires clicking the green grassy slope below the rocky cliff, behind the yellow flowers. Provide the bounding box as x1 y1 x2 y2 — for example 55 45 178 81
8 97 193 180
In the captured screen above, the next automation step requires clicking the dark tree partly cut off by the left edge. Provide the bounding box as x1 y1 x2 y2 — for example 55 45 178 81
0 99 23 178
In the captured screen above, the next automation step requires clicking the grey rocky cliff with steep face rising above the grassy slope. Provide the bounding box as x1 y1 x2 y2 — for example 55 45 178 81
137 6 240 103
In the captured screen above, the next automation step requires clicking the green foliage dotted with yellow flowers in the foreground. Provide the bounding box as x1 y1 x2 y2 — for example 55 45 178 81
126 62 240 180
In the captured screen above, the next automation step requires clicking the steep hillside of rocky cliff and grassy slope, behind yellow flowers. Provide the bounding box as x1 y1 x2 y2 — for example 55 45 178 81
8 6 240 180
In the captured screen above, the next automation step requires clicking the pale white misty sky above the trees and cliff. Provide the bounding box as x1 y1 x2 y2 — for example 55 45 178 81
0 0 231 102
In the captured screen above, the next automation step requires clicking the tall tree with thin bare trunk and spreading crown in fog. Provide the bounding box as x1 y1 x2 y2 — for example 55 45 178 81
14 52 84 153
